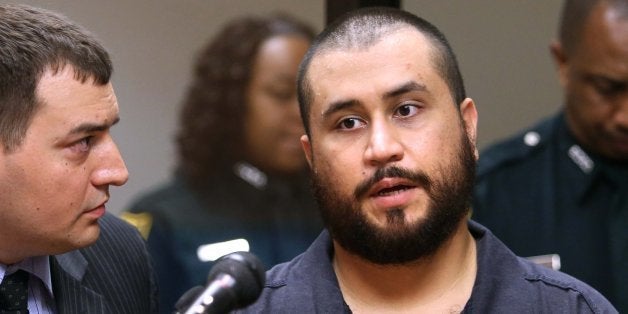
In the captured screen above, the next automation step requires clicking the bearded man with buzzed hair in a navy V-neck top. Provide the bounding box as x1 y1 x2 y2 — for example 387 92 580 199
242 8 616 313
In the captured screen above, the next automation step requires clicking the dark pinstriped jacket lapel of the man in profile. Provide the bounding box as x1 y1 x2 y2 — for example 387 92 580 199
50 250 107 313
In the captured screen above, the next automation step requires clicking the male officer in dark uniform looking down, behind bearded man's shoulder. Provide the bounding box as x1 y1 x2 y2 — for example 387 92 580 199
473 0 628 313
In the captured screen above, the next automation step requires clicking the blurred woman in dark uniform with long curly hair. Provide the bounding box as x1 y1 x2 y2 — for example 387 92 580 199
124 15 322 313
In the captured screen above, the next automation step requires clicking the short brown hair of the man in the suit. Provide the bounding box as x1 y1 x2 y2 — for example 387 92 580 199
0 5 113 152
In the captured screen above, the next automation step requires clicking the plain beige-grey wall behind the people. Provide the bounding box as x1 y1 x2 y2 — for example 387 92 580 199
0 0 561 213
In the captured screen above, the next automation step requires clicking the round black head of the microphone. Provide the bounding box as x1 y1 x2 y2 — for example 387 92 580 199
208 252 266 308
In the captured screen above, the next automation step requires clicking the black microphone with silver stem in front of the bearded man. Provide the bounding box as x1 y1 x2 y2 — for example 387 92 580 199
176 252 266 314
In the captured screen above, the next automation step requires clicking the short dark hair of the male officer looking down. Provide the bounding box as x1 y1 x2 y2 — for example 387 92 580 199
558 0 628 54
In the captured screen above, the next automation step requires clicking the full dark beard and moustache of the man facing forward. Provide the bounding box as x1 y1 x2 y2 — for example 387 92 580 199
312 126 476 265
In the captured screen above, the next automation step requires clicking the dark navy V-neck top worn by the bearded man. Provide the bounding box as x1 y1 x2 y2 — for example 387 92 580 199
240 221 617 313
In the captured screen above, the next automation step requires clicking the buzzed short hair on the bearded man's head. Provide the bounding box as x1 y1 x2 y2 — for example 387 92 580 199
297 7 466 136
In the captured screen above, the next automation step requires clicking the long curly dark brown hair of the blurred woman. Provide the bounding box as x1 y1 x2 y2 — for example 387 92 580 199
176 14 315 185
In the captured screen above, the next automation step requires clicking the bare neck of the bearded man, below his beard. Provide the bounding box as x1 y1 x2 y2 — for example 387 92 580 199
333 219 477 313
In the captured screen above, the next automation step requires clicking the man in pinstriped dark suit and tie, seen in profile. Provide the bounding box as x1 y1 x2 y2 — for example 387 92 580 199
0 5 157 313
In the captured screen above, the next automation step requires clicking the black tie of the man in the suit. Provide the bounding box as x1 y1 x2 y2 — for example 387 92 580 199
0 269 29 314
